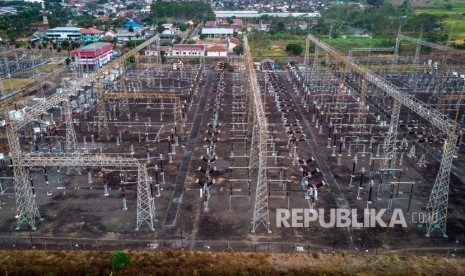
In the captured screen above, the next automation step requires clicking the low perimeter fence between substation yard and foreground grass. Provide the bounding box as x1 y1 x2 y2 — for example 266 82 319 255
0 235 465 258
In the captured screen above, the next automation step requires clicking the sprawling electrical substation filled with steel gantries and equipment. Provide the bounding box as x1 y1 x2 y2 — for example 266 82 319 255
0 30 465 251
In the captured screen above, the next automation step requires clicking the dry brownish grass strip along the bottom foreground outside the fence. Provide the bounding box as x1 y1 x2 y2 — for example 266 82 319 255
0 250 465 275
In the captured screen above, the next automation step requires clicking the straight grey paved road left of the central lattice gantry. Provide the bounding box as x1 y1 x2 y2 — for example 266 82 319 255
164 70 215 226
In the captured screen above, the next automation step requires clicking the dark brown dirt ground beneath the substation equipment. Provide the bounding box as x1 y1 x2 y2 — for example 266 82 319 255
0 58 465 252
